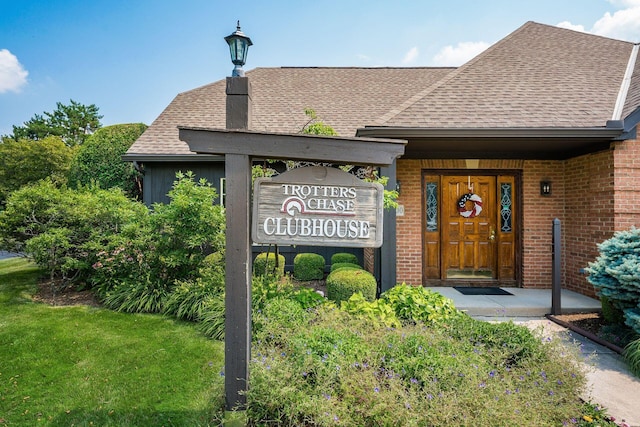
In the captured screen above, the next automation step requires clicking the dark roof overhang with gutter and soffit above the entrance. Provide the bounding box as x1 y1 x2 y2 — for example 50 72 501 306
356 128 624 160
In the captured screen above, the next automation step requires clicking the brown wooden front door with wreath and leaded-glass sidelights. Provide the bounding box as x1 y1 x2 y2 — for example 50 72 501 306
422 171 518 286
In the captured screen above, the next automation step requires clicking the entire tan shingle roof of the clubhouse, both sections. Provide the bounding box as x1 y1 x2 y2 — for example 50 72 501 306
128 22 640 156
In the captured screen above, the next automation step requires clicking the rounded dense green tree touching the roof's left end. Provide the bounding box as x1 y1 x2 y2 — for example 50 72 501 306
69 123 147 199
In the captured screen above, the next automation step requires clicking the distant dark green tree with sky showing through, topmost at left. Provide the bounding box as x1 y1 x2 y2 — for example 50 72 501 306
11 99 102 147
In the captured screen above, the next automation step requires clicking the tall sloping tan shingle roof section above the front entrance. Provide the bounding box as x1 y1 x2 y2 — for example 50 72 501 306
378 22 633 128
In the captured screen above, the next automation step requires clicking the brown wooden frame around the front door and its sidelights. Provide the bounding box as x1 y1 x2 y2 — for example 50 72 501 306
420 169 524 287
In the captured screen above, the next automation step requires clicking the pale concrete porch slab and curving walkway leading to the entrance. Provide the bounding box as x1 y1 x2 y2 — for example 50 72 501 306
430 287 640 427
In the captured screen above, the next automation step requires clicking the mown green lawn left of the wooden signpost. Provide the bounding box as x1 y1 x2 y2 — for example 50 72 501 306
0 259 224 426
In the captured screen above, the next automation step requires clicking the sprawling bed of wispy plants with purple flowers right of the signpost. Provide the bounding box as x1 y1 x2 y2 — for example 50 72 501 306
247 302 585 427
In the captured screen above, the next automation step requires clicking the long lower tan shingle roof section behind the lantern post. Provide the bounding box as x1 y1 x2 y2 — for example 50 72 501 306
128 68 454 154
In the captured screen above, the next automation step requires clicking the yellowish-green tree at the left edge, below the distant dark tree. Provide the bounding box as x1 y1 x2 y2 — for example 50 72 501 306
0 136 73 205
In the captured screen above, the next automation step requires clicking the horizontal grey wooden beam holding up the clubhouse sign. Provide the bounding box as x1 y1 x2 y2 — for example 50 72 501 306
178 127 407 166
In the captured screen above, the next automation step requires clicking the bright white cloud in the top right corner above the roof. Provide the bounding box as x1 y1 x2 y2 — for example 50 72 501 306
558 0 640 42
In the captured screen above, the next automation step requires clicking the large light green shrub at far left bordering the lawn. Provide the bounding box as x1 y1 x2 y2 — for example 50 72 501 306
0 180 148 282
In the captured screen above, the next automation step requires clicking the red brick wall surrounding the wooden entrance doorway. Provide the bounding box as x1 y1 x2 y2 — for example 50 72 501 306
397 132 640 296
